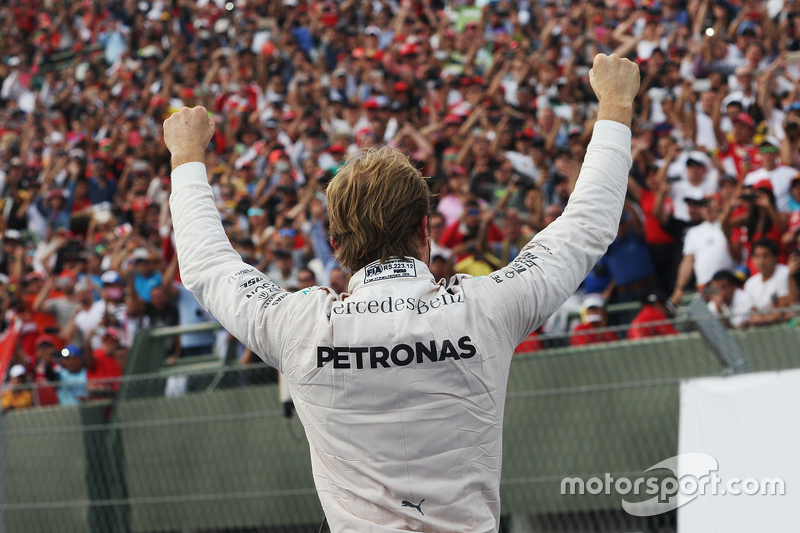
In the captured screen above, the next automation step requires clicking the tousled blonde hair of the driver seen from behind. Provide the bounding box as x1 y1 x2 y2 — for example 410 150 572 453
327 147 431 271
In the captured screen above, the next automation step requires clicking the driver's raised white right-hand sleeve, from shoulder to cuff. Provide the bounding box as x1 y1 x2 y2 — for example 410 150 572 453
465 120 632 345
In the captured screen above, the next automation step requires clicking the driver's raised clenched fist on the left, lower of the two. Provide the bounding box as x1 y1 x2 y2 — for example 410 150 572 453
164 107 214 168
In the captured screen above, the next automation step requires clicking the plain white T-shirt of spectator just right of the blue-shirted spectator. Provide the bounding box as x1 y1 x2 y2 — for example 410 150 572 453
683 221 736 286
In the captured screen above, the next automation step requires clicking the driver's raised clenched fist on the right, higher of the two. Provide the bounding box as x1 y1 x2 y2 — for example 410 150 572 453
589 54 641 126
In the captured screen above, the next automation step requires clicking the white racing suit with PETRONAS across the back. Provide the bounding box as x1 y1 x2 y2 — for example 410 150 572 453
170 121 631 533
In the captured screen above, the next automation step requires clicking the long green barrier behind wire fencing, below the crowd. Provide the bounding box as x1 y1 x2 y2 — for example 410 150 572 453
0 312 800 533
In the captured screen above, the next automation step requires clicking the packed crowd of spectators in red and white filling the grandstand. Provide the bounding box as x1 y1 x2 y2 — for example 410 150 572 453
0 0 800 408
